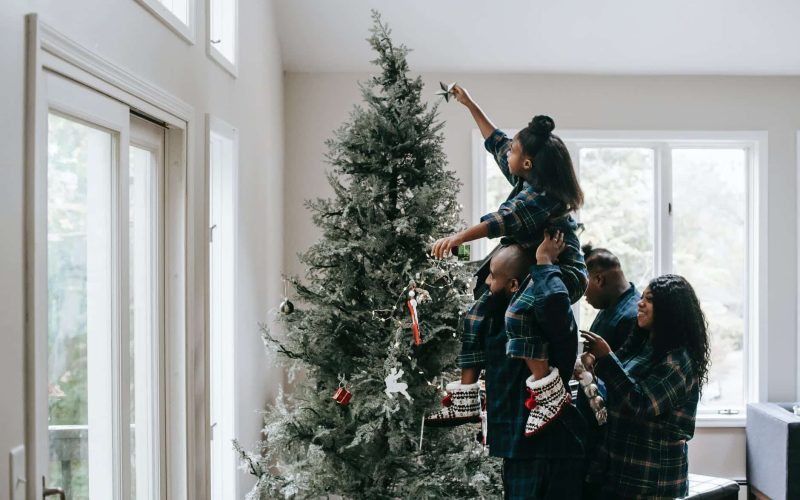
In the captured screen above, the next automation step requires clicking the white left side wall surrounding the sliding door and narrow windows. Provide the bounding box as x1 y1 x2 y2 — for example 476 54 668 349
0 0 283 498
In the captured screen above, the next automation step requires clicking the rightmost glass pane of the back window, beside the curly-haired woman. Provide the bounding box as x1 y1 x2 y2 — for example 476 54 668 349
672 149 747 406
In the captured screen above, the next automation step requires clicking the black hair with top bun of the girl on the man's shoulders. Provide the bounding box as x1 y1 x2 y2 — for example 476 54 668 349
516 115 583 211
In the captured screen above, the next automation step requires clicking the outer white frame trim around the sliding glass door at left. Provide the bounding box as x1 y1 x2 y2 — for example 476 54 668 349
24 14 208 498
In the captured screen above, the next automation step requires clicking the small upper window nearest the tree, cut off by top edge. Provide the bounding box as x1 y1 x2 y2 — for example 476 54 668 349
208 0 239 77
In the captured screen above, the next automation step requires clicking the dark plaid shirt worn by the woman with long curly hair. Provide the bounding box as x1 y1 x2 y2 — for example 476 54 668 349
590 333 700 498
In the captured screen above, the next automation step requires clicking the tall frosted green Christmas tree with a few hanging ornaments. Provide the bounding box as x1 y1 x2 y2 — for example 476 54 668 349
236 12 501 499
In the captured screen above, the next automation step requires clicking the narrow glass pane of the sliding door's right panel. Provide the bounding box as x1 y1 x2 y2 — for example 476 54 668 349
129 146 158 498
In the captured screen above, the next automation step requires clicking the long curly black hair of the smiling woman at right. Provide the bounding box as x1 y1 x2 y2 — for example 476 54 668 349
648 274 711 387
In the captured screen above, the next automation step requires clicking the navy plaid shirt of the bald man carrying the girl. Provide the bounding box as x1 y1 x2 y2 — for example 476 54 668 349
482 266 586 459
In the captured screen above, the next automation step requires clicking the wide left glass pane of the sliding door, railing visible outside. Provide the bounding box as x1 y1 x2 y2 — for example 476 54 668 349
47 114 113 499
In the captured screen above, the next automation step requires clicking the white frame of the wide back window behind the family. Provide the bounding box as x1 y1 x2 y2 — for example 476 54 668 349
472 129 764 427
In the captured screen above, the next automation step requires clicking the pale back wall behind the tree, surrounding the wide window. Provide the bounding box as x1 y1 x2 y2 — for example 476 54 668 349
284 72 800 477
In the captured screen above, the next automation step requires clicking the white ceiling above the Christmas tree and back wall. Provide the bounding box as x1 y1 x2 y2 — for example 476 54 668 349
274 0 800 75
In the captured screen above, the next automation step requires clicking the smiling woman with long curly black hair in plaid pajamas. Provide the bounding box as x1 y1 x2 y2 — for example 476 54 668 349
583 274 709 498
